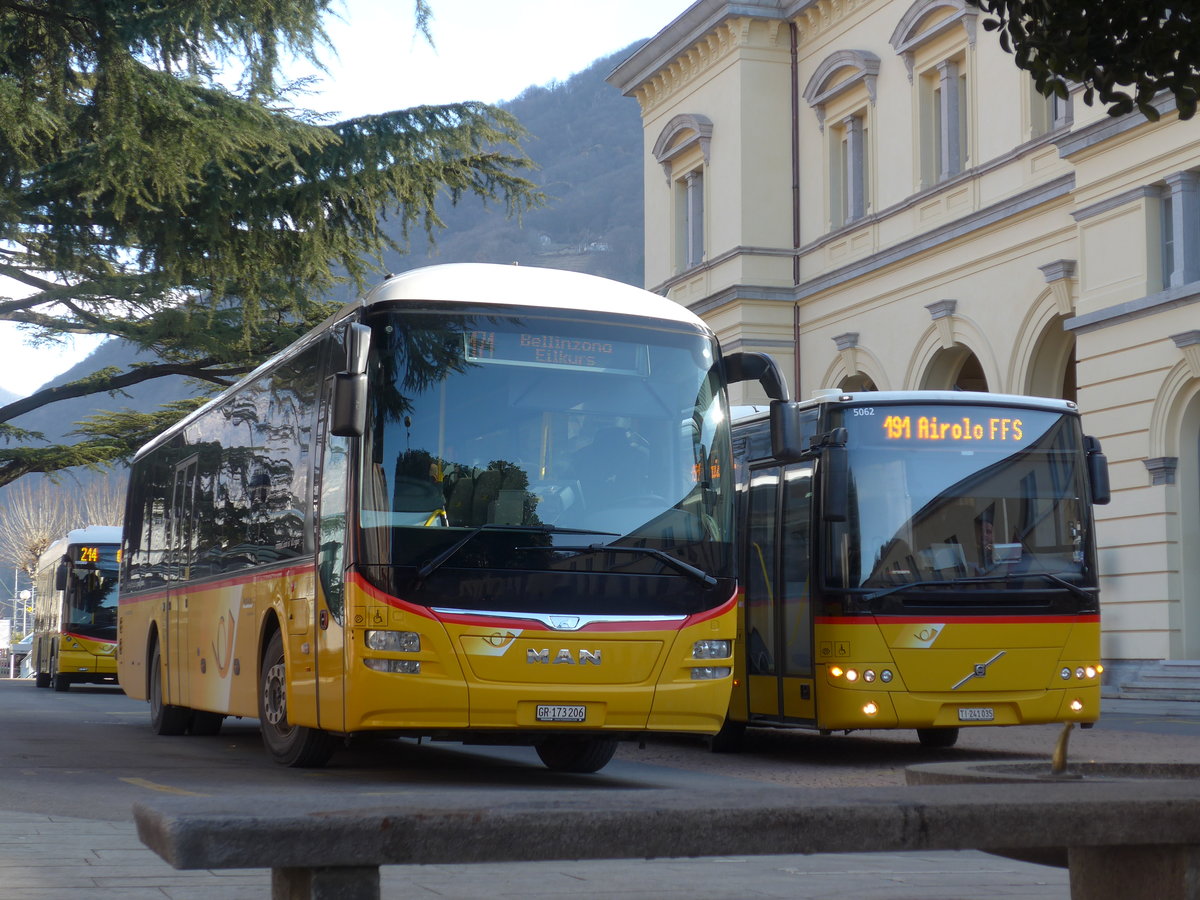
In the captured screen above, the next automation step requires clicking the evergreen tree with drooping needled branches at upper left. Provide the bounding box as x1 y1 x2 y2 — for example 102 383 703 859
0 0 540 485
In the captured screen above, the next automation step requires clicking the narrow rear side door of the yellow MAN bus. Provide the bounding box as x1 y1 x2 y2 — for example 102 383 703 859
161 456 199 707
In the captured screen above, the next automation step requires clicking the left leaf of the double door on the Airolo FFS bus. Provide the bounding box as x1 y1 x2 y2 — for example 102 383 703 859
744 467 782 724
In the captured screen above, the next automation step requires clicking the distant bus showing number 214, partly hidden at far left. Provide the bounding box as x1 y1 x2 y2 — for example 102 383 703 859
29 526 121 691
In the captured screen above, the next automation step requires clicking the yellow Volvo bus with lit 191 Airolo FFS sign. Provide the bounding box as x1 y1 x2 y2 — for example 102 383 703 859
713 391 1109 750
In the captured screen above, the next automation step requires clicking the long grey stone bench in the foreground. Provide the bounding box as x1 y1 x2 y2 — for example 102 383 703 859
133 780 1200 900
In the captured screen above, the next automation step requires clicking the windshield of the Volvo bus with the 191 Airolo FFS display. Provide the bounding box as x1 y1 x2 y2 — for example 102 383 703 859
827 404 1096 599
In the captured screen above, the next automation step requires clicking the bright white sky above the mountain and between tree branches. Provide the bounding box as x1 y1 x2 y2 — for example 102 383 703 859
0 0 691 396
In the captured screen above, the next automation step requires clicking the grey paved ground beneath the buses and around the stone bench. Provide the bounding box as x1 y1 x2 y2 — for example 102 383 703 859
0 679 1200 900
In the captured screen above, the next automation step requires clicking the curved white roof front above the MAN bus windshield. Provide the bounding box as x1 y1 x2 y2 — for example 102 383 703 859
362 263 708 331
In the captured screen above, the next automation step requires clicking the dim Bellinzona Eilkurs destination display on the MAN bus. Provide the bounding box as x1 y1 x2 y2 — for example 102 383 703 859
463 331 646 374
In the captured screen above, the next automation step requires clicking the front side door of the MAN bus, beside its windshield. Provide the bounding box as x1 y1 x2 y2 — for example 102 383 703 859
313 391 350 731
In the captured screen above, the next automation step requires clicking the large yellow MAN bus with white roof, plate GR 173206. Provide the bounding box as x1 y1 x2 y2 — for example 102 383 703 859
119 264 786 772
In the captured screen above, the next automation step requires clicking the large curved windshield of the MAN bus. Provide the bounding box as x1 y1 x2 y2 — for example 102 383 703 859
359 305 733 612
